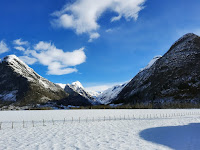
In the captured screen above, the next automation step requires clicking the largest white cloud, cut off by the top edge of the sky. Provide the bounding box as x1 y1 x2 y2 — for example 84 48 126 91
51 0 146 41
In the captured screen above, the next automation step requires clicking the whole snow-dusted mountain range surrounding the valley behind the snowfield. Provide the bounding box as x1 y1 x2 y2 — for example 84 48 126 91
0 33 200 107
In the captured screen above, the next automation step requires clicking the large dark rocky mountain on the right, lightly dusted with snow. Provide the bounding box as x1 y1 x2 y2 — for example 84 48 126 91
115 33 200 104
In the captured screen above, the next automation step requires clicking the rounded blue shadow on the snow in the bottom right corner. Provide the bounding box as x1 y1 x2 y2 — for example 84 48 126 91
140 123 200 150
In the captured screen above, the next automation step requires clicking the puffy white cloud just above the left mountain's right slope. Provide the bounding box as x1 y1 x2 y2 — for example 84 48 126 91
24 41 86 75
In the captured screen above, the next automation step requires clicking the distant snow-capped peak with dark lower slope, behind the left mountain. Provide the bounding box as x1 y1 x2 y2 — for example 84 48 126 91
61 81 98 106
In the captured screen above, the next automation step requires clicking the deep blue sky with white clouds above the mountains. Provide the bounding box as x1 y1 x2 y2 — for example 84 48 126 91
0 0 200 90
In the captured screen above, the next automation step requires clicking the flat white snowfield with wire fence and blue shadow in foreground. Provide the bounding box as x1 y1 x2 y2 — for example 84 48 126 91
0 109 200 150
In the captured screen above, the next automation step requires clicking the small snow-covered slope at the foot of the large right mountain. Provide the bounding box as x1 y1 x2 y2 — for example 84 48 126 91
97 83 127 104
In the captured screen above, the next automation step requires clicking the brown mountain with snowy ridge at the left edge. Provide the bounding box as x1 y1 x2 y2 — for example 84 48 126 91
0 55 68 106
